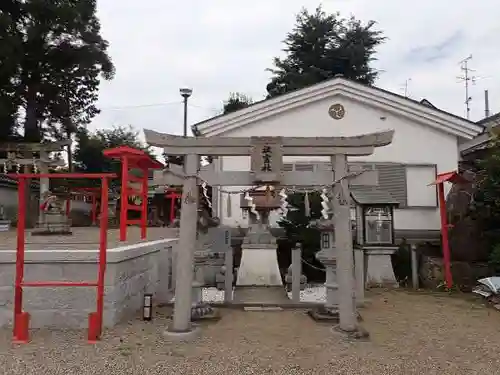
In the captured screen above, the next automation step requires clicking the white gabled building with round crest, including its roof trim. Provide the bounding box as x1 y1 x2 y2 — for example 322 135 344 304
192 77 483 242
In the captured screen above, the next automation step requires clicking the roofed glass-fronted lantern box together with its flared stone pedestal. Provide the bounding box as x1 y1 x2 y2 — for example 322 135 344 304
351 188 399 287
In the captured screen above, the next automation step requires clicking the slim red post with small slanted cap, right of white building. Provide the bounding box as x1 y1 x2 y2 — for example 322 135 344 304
429 171 468 289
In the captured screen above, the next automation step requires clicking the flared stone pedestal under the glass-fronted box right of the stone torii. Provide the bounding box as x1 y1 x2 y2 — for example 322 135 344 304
363 246 399 288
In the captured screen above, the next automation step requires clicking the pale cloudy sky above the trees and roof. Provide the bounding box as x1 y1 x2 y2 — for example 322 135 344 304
91 0 500 134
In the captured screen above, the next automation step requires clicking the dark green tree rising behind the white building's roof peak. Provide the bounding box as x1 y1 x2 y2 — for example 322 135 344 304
267 6 385 97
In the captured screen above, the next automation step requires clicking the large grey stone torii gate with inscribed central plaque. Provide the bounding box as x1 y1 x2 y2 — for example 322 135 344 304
144 129 394 337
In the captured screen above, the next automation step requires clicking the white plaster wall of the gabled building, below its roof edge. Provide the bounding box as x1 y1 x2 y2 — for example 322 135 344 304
213 96 458 229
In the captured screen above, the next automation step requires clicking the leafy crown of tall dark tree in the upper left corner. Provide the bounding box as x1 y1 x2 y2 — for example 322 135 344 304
0 0 114 142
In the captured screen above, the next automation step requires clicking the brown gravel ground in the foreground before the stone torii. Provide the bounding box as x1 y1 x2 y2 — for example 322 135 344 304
0 291 500 375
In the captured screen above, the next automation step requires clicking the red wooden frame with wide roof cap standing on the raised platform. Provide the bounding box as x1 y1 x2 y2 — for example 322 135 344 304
103 146 164 241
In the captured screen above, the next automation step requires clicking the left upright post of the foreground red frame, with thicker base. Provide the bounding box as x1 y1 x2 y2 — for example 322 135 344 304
13 177 29 342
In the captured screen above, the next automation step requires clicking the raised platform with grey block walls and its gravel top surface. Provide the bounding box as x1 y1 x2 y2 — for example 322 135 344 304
0 228 176 329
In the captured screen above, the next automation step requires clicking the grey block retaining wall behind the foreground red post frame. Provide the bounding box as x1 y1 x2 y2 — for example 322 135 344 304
0 239 175 328
